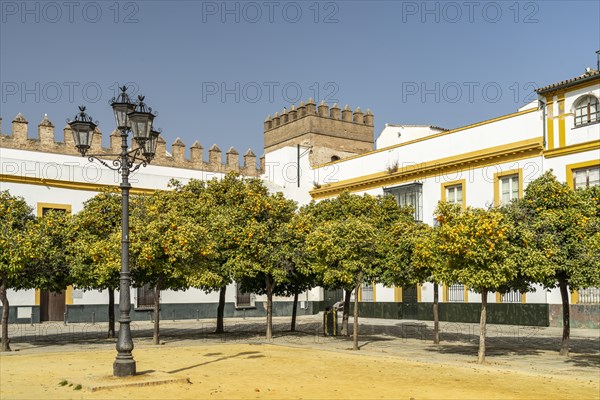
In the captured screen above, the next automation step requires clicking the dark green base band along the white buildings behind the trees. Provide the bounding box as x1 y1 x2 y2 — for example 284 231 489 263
0 301 600 329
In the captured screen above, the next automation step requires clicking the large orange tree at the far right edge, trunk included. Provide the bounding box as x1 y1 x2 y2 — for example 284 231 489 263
505 171 600 355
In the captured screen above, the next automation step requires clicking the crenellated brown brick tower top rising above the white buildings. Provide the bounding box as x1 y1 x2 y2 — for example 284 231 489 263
264 98 374 166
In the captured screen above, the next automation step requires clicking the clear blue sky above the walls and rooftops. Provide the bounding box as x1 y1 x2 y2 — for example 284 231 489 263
0 0 600 157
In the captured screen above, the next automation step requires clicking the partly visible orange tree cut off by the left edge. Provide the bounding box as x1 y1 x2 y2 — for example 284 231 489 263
0 191 34 351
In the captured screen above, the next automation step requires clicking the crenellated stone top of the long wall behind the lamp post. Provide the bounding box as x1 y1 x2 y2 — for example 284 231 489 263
0 113 260 176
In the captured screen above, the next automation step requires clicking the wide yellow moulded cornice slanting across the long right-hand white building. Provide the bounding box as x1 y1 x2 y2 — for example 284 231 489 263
310 137 543 199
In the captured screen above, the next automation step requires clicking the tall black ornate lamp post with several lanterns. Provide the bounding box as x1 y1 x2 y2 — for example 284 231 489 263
69 86 159 377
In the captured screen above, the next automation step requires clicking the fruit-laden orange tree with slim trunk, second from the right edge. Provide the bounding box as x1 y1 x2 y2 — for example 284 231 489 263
436 205 518 363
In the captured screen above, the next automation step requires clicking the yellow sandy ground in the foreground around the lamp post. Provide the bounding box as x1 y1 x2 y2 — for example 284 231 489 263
0 318 600 399
